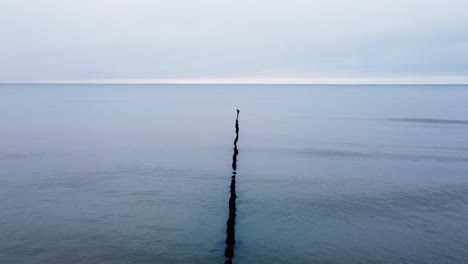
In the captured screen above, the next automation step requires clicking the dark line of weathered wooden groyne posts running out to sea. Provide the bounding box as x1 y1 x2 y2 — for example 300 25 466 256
224 109 239 264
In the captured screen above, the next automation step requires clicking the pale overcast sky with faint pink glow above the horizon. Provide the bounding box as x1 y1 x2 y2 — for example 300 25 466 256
0 0 468 83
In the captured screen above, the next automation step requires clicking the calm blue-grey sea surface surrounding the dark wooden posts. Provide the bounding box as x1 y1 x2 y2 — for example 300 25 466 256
0 84 468 264
